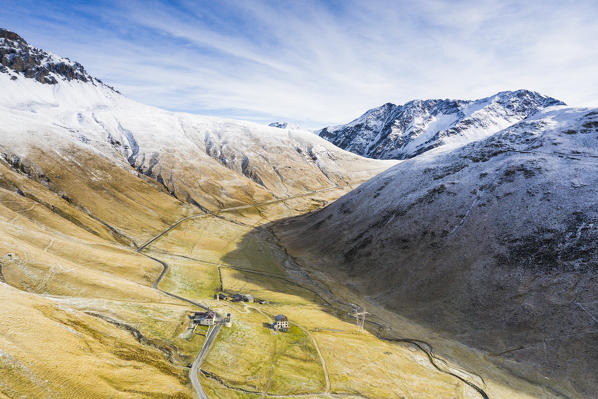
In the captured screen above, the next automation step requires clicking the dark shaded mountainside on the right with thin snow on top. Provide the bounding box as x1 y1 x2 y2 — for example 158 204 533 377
276 107 598 398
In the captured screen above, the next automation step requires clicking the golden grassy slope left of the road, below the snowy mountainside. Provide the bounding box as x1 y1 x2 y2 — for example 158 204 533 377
0 152 202 398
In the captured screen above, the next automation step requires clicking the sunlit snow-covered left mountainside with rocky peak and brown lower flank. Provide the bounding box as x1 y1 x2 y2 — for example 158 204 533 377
0 30 391 238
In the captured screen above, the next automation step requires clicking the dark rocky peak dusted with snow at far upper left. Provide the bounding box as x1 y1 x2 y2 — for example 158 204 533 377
0 29 116 91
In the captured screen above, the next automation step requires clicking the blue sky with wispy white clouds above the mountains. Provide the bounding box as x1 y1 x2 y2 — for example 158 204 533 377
0 0 598 128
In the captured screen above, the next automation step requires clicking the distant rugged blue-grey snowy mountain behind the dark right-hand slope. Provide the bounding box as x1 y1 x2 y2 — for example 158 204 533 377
316 90 565 159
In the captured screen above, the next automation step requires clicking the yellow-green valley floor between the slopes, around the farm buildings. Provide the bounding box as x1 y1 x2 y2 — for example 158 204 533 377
134 193 560 398
